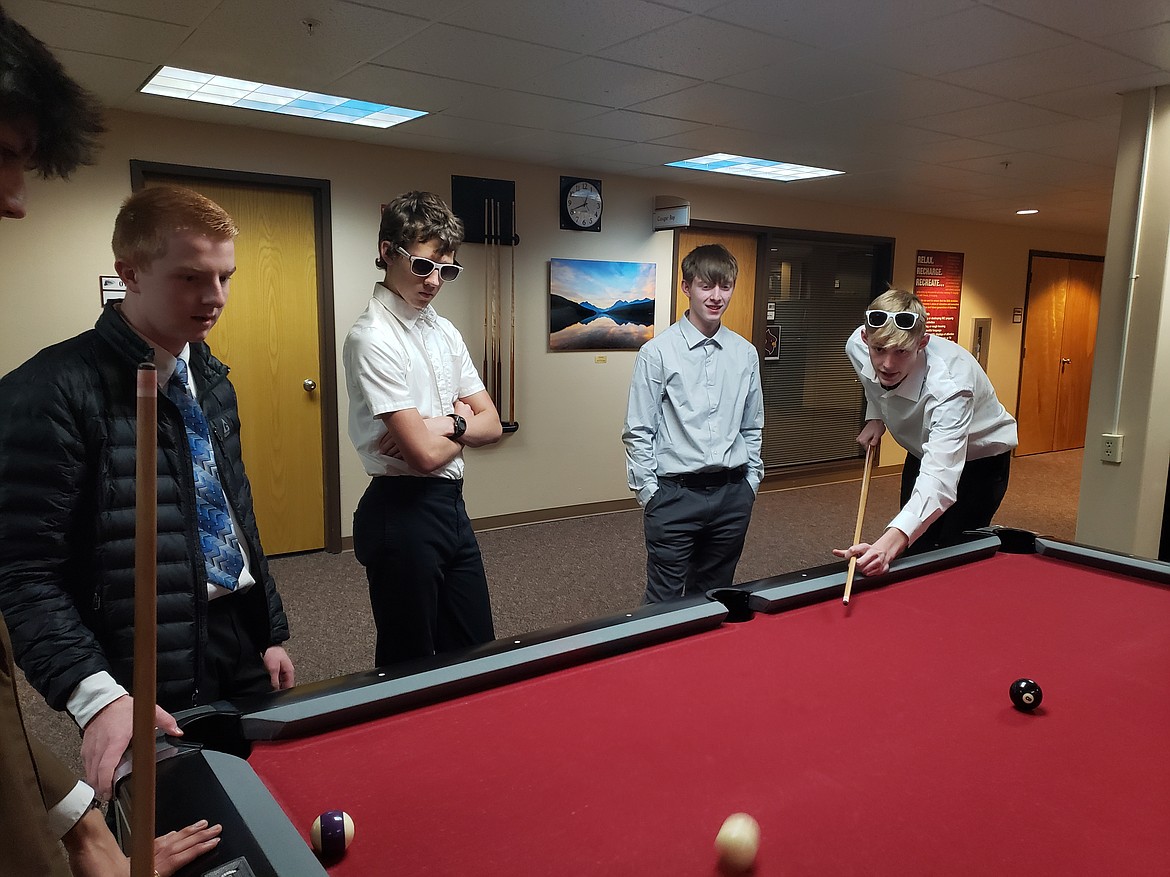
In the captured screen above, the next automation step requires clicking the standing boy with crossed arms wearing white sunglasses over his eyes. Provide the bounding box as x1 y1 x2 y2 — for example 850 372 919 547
343 192 502 667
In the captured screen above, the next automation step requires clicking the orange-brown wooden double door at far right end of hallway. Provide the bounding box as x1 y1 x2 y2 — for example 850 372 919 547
1016 256 1103 455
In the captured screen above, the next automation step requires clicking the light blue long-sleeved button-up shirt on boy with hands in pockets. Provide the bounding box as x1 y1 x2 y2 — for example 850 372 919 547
621 317 764 506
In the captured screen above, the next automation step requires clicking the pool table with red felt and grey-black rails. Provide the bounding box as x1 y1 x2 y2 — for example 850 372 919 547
119 531 1170 877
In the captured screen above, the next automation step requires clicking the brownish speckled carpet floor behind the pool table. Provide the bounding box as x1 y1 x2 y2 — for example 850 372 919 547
21 450 1083 771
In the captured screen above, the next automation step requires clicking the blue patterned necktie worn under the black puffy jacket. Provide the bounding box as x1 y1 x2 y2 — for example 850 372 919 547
166 359 243 591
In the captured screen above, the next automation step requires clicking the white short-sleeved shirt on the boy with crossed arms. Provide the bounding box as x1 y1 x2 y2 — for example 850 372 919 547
342 283 483 479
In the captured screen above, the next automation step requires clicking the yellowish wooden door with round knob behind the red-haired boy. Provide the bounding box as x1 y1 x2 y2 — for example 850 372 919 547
146 177 325 554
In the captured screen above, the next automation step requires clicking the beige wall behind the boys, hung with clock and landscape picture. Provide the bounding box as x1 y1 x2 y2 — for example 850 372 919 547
0 112 1104 534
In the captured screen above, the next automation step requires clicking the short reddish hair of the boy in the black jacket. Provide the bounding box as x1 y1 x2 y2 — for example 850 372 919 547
111 186 240 268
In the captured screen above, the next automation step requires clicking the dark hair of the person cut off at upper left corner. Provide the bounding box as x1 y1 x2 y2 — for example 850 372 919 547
0 3 105 179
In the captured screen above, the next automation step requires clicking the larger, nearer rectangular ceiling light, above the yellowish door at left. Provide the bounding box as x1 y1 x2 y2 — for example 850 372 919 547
139 67 427 127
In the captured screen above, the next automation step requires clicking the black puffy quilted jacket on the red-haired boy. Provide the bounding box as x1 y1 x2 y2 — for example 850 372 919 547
0 306 289 711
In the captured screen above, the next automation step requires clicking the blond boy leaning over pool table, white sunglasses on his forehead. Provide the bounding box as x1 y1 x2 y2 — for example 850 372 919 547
833 289 1017 575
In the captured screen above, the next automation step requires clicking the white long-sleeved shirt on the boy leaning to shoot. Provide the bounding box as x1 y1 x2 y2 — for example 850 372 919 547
846 329 1018 543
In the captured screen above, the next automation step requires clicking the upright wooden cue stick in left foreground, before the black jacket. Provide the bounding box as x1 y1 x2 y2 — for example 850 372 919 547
130 362 158 877
